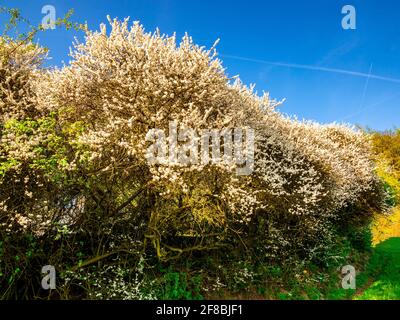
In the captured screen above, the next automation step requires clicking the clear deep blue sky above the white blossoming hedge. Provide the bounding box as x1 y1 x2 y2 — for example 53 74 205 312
0 0 400 130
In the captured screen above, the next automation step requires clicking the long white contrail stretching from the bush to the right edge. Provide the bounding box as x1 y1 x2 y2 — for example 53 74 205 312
220 54 400 83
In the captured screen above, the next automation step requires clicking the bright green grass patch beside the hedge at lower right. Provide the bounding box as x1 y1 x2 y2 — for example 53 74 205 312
355 237 400 300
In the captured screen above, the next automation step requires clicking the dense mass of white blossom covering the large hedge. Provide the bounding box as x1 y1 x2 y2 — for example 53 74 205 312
0 20 378 257
